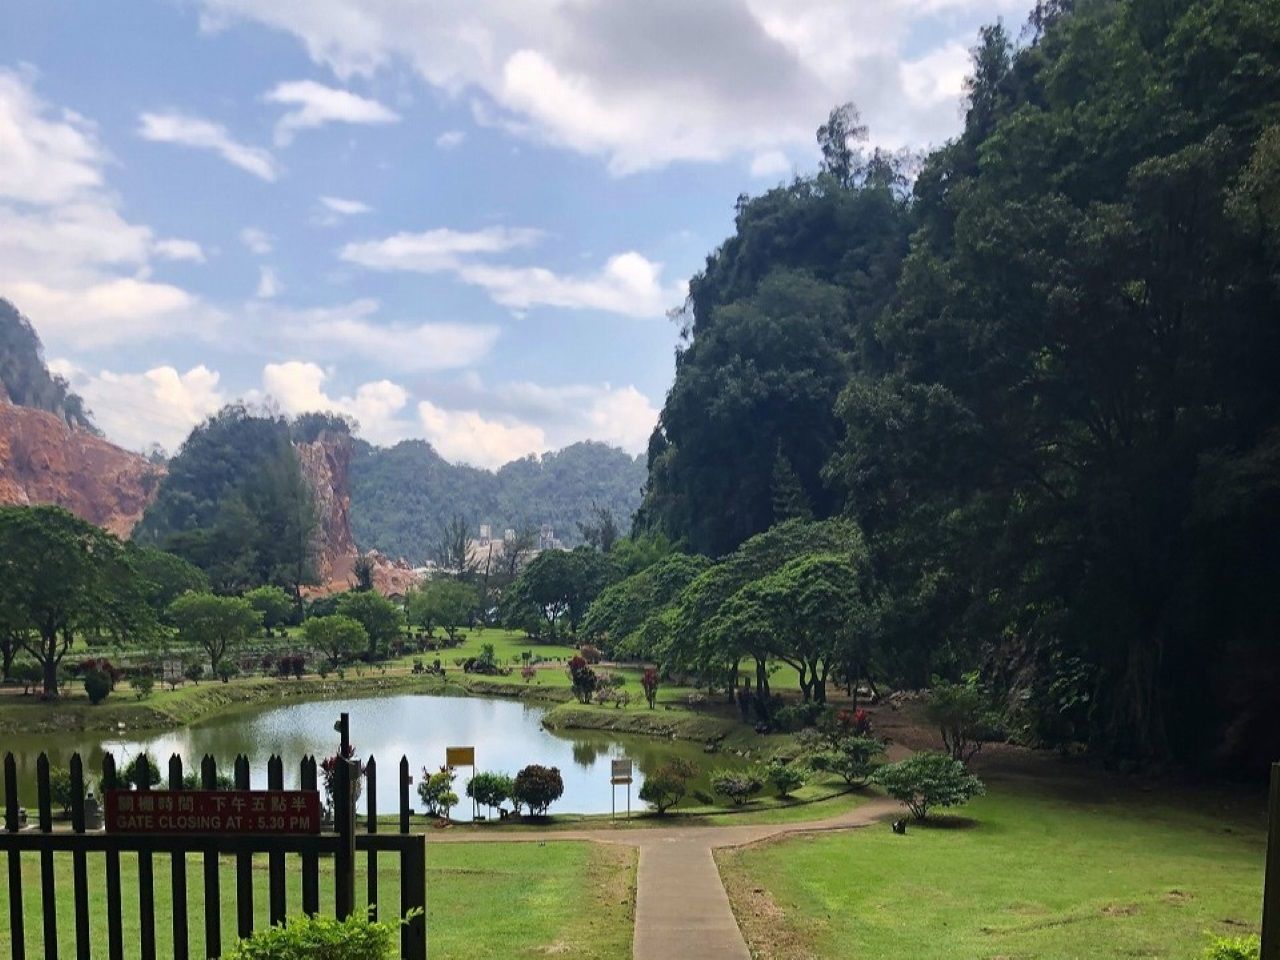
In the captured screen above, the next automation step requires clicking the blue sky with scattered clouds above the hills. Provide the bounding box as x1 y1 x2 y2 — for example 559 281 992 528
0 0 1027 467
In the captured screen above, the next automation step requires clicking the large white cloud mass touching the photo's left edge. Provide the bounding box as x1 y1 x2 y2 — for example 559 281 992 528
0 69 218 349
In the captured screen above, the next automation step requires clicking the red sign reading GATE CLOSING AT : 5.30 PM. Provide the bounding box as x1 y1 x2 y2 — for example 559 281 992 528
106 790 320 833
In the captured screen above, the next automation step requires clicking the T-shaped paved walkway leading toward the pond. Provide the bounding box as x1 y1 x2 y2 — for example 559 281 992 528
429 799 902 960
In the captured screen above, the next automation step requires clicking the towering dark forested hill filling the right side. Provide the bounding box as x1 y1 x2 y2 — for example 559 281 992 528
640 0 1280 764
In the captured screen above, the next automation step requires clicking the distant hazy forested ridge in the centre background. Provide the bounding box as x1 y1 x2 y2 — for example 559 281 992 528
351 440 645 562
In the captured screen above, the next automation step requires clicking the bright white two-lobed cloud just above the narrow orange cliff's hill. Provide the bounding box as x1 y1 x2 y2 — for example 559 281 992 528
262 360 415 444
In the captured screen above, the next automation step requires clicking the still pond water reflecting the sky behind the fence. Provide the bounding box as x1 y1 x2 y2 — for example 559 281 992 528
0 694 733 815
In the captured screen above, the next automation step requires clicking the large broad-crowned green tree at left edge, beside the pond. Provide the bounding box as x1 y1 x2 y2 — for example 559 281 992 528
0 507 155 698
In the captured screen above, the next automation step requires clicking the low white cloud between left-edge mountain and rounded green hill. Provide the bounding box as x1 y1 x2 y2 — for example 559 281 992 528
49 360 225 452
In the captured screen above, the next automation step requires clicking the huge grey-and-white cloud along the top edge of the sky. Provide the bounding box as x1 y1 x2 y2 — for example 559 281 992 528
201 0 1028 175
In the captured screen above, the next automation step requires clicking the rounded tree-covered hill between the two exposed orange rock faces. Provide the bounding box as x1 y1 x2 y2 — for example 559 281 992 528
133 404 319 598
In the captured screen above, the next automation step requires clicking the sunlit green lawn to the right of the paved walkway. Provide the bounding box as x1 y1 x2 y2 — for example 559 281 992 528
718 781 1266 960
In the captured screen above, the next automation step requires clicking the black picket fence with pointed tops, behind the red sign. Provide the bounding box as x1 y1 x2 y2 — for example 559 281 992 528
0 754 426 960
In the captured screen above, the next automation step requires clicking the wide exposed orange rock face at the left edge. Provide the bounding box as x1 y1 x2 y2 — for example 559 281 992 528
0 396 165 536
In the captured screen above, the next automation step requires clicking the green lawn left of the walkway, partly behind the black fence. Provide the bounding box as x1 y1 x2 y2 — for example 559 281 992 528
0 841 635 960
